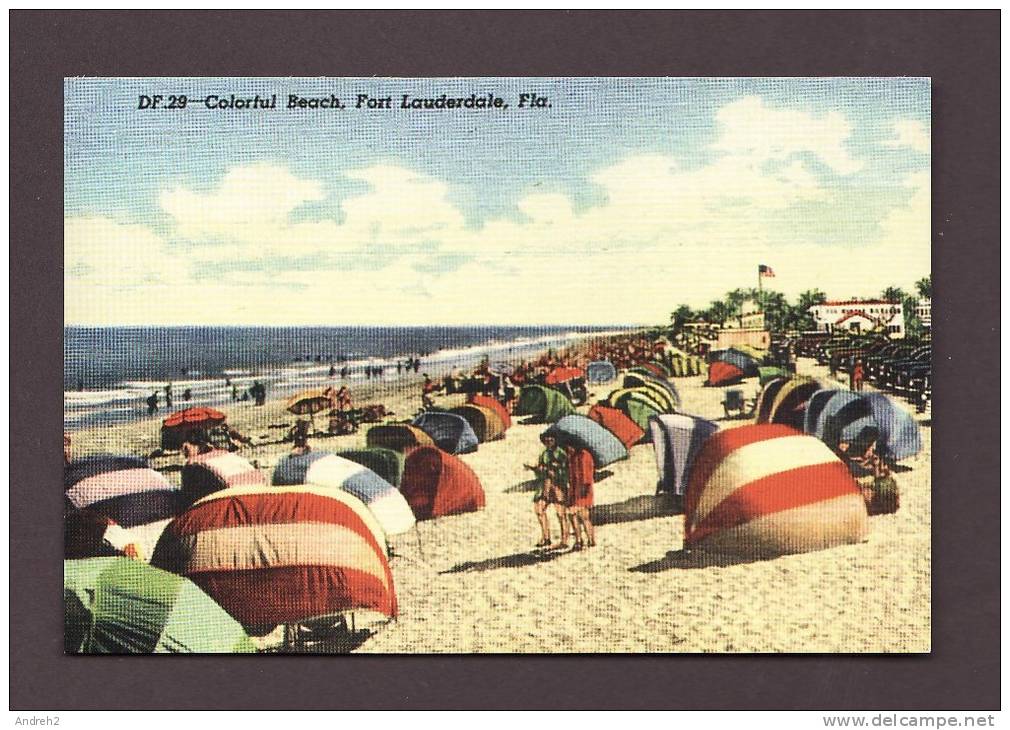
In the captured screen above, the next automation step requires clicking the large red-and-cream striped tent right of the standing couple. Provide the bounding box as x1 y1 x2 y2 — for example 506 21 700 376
684 424 869 557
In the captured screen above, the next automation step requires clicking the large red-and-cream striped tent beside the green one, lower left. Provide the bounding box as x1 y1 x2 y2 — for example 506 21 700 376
152 485 397 633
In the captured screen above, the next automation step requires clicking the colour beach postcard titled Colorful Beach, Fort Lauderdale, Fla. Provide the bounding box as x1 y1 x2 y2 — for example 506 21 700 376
64 78 932 654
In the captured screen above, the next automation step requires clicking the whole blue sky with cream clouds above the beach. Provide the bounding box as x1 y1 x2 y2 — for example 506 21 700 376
64 78 930 325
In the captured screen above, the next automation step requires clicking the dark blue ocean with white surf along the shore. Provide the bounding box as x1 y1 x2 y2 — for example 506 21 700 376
64 325 629 429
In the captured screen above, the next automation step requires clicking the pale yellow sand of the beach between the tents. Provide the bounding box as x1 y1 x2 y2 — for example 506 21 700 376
74 359 931 653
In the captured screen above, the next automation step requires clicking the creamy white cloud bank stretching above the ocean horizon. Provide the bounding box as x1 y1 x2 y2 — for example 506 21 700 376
67 98 929 324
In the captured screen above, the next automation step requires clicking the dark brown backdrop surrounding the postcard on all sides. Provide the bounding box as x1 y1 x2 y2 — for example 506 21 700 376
9 11 1000 710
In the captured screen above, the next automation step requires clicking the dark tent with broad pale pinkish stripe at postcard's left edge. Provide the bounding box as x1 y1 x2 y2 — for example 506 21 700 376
64 454 182 527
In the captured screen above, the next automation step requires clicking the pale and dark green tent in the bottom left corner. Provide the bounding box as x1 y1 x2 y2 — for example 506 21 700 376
64 557 256 654
